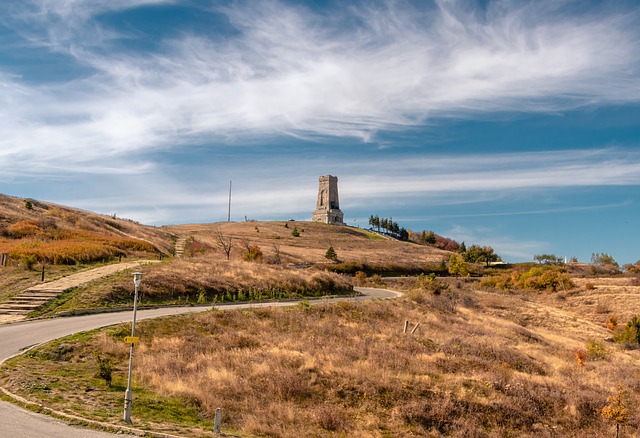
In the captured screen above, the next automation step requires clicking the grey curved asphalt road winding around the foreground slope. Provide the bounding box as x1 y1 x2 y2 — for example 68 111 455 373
0 288 401 438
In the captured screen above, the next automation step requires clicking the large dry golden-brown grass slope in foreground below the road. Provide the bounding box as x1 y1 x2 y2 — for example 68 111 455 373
3 281 640 437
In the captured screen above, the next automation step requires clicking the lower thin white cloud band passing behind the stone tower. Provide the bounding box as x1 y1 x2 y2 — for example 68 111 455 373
41 148 640 228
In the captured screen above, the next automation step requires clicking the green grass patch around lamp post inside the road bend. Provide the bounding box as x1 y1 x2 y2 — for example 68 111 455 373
0 326 213 436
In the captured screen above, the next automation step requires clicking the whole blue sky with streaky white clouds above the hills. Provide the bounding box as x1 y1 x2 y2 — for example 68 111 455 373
0 0 640 265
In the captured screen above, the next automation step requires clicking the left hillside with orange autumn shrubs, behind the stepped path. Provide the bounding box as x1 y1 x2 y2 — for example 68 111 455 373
0 194 174 300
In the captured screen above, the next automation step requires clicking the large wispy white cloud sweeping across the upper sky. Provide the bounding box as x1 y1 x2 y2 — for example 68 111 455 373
0 0 640 175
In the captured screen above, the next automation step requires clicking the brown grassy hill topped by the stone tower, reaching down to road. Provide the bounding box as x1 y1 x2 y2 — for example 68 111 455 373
21 222 456 315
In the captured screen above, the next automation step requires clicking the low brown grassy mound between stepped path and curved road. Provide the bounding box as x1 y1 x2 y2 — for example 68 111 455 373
30 253 354 316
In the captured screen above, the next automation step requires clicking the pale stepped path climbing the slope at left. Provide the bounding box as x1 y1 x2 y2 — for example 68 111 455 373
0 260 159 324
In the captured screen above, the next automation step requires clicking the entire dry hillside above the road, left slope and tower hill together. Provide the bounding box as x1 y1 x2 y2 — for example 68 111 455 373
0 195 460 316
